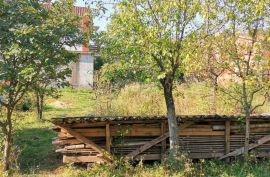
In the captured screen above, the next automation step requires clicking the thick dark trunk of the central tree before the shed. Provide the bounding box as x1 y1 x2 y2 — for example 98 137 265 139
163 76 179 155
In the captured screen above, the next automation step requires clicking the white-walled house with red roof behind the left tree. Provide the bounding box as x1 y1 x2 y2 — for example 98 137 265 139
44 3 94 88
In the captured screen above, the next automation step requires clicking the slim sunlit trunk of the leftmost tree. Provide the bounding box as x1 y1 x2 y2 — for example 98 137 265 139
3 109 12 171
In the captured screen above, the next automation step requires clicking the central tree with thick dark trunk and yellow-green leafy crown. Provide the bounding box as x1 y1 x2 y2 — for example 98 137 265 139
102 0 203 154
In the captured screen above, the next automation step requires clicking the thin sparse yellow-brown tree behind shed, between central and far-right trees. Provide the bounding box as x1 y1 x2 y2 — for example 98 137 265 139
186 0 226 114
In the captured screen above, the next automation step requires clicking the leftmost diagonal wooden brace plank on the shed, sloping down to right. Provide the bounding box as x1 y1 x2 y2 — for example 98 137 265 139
57 124 112 162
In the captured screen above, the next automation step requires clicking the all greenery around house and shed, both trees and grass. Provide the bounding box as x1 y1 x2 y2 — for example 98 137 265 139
0 0 270 176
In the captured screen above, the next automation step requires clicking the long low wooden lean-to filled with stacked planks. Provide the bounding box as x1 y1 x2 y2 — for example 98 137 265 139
52 115 270 163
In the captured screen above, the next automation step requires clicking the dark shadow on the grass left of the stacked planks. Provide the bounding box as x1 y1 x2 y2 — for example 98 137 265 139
14 128 62 173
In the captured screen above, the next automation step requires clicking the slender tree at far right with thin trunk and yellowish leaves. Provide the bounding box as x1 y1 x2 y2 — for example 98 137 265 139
207 0 270 157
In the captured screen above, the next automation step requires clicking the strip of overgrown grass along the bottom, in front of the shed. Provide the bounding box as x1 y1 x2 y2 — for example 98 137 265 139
20 161 270 177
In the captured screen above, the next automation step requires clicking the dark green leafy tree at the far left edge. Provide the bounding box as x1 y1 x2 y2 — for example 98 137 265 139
0 0 89 171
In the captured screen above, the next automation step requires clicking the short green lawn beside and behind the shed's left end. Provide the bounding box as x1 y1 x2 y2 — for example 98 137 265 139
11 89 96 173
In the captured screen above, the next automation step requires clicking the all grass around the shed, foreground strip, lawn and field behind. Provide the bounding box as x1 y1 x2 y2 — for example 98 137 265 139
0 84 270 177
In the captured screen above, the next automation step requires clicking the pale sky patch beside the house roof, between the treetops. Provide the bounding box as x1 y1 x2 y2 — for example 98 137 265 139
75 0 113 31
